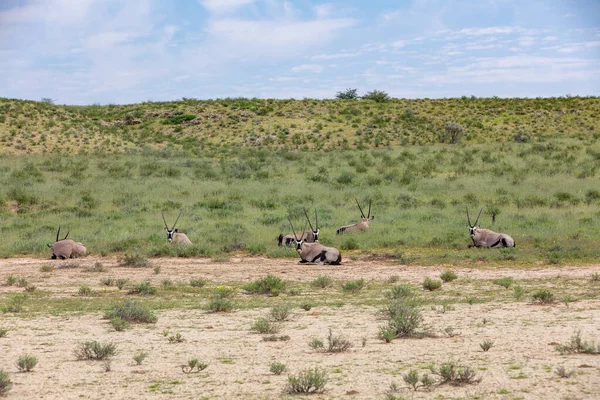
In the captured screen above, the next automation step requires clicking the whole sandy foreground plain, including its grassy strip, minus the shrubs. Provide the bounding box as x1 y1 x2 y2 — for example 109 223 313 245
0 256 600 399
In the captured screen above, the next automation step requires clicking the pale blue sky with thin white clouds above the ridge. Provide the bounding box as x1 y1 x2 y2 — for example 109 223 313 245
0 0 600 104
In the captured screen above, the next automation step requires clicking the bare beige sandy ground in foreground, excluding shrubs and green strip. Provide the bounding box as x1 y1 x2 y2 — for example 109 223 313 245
0 258 600 399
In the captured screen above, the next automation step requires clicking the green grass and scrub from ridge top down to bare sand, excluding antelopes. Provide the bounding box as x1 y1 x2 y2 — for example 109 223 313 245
0 98 600 266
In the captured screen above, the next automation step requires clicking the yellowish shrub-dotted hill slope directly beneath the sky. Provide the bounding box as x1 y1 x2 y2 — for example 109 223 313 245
0 97 600 155
